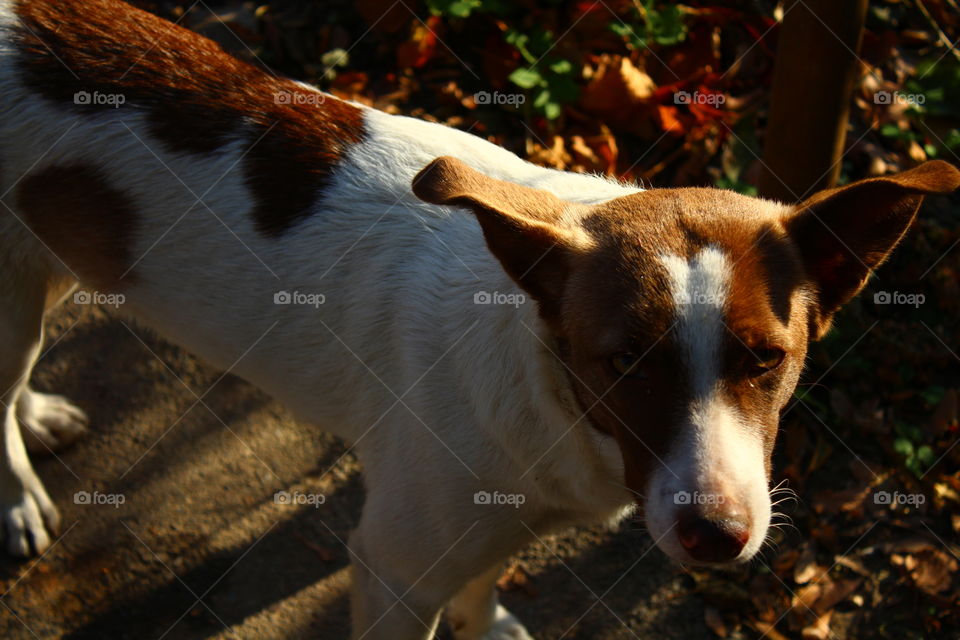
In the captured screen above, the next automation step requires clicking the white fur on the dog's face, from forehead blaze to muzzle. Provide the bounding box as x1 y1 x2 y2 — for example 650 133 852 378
646 246 770 562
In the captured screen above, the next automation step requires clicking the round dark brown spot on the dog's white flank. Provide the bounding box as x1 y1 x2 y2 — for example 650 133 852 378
16 165 137 291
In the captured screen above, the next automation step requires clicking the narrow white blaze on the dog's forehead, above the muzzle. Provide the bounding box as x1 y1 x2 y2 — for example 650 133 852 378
661 246 730 398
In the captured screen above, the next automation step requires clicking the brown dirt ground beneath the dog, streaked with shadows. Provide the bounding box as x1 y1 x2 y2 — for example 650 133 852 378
0 303 720 640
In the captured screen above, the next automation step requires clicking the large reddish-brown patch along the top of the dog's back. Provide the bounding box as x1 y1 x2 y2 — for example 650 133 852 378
17 0 364 237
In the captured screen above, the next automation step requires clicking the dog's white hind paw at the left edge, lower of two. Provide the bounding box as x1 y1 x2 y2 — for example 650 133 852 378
0 472 60 558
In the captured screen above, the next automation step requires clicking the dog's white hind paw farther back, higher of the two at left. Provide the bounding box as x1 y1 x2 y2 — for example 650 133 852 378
17 389 89 454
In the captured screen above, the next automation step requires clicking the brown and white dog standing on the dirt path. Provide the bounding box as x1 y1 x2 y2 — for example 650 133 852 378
0 0 960 640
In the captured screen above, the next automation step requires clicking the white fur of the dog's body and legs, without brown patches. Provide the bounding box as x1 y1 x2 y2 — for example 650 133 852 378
0 1 638 638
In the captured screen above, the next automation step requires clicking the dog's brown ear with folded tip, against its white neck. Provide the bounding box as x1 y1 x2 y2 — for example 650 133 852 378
413 156 589 319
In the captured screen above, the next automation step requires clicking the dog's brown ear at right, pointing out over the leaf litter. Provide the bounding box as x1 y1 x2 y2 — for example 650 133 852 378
785 160 960 339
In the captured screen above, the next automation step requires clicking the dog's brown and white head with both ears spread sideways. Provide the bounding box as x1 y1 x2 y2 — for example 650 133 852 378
413 157 960 563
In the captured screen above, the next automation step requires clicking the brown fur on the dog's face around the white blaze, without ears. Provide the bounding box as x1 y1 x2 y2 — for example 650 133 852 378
562 188 808 493
